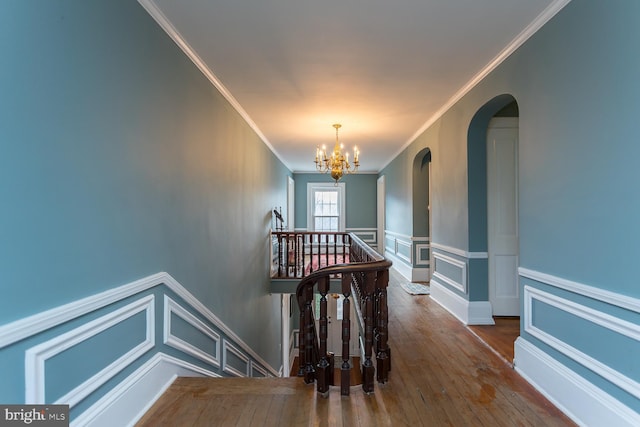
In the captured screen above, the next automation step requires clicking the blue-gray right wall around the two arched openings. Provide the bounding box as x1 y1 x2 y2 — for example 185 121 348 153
382 0 640 412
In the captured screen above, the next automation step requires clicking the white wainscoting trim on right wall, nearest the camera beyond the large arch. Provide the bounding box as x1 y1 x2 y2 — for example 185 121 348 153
514 268 640 426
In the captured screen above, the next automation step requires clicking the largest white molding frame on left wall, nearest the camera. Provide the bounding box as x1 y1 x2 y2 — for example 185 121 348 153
25 295 155 408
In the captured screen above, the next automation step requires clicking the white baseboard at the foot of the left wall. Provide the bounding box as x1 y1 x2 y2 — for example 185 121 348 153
71 353 220 427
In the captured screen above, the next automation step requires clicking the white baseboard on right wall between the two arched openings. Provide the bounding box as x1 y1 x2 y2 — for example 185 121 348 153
430 278 495 325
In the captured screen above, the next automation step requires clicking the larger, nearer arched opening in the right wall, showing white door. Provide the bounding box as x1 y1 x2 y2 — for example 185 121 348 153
467 94 521 362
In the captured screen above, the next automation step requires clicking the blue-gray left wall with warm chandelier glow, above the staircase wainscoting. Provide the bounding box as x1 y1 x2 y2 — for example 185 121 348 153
0 0 290 414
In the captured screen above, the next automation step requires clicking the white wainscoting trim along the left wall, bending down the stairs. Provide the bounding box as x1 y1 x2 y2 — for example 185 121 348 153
0 272 279 425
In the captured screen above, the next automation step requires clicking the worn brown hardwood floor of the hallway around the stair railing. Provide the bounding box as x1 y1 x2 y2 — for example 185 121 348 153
138 271 574 427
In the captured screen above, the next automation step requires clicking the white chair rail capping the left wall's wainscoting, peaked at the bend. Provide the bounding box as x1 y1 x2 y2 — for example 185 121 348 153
0 272 277 375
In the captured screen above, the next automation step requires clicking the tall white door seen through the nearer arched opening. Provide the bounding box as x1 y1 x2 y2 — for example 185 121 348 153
487 118 520 316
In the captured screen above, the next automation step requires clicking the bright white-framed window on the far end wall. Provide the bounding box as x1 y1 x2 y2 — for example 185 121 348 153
307 183 345 231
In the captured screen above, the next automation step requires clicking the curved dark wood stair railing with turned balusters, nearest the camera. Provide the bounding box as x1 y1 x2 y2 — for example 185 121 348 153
296 234 391 396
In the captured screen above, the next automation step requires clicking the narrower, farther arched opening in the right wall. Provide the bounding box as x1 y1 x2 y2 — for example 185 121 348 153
412 148 433 282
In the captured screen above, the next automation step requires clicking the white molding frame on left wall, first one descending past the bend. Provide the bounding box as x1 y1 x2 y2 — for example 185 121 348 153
162 295 220 367
